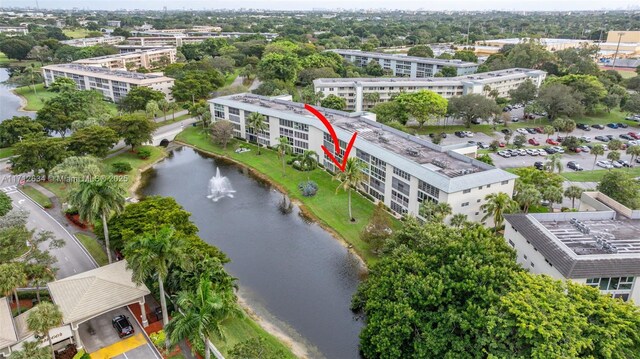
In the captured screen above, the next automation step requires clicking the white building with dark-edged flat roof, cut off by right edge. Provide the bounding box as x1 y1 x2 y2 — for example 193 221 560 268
504 192 640 305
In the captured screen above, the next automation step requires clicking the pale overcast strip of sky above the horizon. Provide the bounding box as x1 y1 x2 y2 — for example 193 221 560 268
0 0 640 11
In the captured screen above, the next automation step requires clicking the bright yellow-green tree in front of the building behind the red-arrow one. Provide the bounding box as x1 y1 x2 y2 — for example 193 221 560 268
395 90 447 127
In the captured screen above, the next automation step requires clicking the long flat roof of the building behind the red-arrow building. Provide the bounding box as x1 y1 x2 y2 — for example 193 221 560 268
314 68 546 86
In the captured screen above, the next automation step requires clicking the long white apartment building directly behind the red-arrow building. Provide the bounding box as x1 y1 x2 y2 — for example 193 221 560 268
313 68 547 111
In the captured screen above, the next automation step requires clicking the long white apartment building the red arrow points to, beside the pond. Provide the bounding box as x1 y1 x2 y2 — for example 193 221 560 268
209 94 516 222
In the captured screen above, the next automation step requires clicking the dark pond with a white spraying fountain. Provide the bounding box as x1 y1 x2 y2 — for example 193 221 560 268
142 147 363 359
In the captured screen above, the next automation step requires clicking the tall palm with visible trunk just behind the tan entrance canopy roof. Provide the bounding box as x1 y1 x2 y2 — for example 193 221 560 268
68 179 125 263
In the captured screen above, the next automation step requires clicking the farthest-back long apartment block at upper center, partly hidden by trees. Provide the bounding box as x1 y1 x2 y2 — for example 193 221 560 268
328 49 478 77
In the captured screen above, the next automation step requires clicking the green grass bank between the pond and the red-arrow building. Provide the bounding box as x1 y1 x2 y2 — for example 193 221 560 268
176 127 399 264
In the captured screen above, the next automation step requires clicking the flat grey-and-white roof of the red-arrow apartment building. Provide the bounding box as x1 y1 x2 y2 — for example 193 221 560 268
210 94 516 193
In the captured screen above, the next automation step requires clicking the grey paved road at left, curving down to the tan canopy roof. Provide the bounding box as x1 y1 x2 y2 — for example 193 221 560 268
0 186 97 279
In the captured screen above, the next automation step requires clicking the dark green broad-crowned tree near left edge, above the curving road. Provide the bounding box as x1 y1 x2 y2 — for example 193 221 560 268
11 135 68 181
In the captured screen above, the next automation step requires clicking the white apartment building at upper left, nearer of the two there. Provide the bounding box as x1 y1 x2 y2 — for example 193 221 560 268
42 64 173 102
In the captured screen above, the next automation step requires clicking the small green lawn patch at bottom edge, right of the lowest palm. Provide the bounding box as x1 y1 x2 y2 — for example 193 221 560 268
212 316 295 359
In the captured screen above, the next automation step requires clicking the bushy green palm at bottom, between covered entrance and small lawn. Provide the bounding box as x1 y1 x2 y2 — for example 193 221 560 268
166 277 242 359
